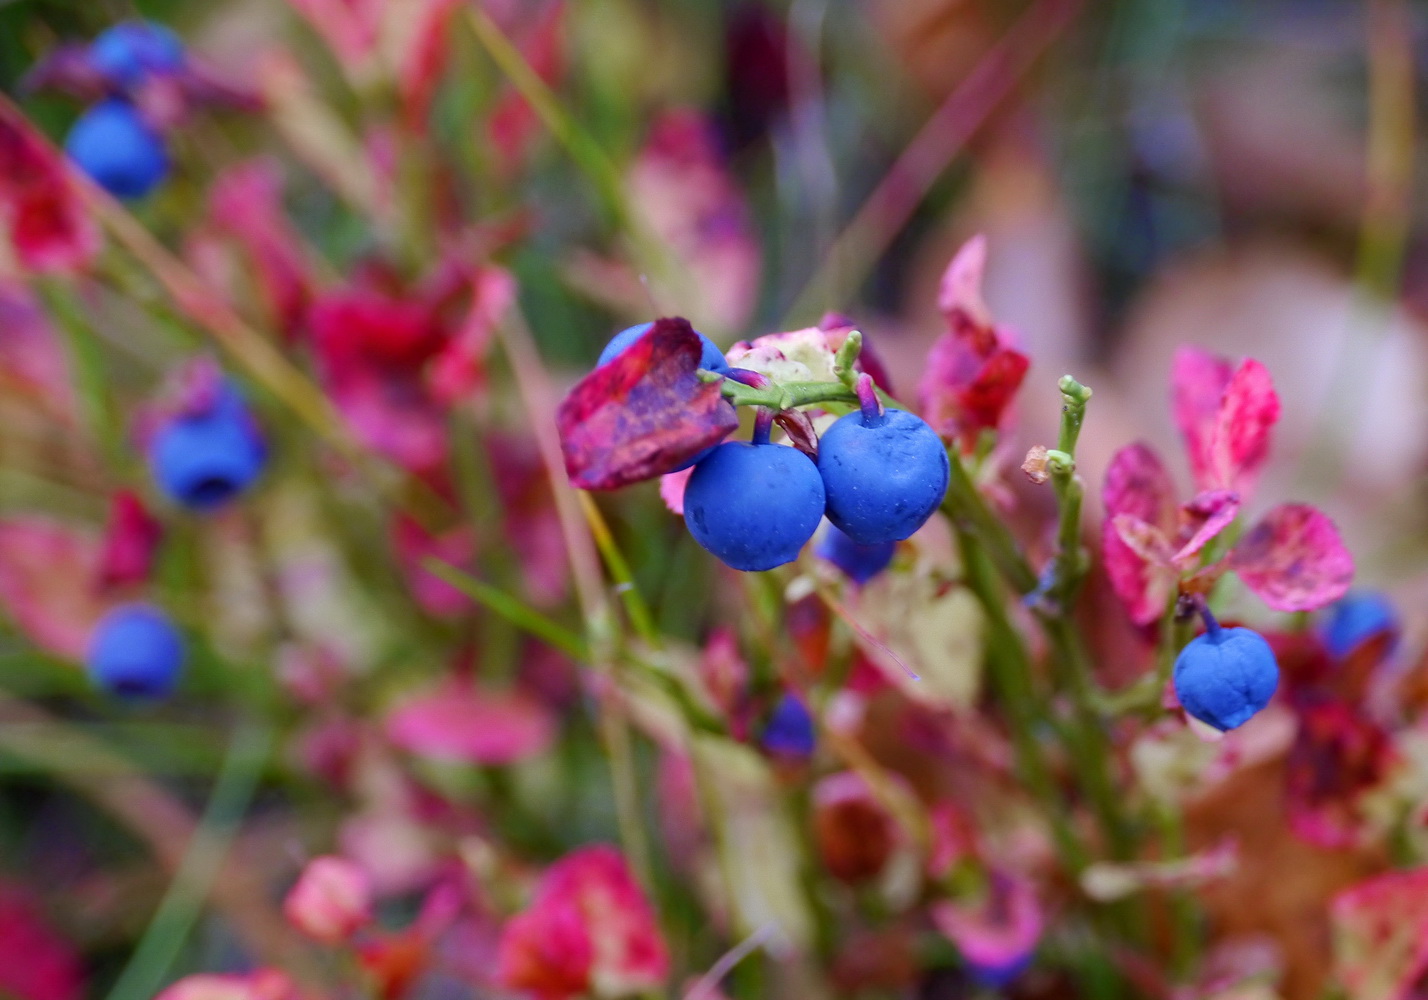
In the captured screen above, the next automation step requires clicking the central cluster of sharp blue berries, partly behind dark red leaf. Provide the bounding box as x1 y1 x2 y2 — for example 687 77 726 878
600 324 951 583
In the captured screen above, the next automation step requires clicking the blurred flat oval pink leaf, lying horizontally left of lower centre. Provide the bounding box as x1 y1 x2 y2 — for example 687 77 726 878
386 680 555 764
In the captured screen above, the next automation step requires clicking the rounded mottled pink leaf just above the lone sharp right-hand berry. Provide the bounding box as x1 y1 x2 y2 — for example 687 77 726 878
1230 503 1354 611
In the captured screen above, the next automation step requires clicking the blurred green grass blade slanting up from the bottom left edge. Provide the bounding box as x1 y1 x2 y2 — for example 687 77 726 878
109 726 273 1000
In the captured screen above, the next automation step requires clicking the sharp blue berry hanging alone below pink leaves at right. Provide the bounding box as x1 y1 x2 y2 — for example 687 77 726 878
1175 620 1279 730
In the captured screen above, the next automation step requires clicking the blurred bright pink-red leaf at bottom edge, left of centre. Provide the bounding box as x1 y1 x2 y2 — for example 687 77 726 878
498 844 670 1000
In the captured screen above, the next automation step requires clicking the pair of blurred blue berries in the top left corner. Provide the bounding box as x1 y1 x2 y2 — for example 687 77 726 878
64 21 184 199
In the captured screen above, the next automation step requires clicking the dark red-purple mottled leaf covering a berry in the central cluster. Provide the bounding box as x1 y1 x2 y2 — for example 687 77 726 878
555 319 738 490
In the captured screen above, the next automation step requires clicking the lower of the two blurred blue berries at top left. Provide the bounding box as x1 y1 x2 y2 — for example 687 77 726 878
64 97 169 199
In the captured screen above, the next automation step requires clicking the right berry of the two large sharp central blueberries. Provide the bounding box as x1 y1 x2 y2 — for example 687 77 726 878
818 410 951 546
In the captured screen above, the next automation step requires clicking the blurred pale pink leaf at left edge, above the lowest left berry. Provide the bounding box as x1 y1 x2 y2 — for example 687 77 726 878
0 517 109 660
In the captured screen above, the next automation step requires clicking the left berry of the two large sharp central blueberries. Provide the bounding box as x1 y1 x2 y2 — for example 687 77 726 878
684 441 824 571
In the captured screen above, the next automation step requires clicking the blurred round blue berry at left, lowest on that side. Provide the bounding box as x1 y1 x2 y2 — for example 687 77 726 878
86 604 183 701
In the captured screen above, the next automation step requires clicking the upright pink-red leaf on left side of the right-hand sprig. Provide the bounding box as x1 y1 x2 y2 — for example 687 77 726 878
1101 444 1175 624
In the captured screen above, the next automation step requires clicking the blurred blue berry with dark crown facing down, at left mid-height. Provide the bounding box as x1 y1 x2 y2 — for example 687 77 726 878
149 383 267 511
